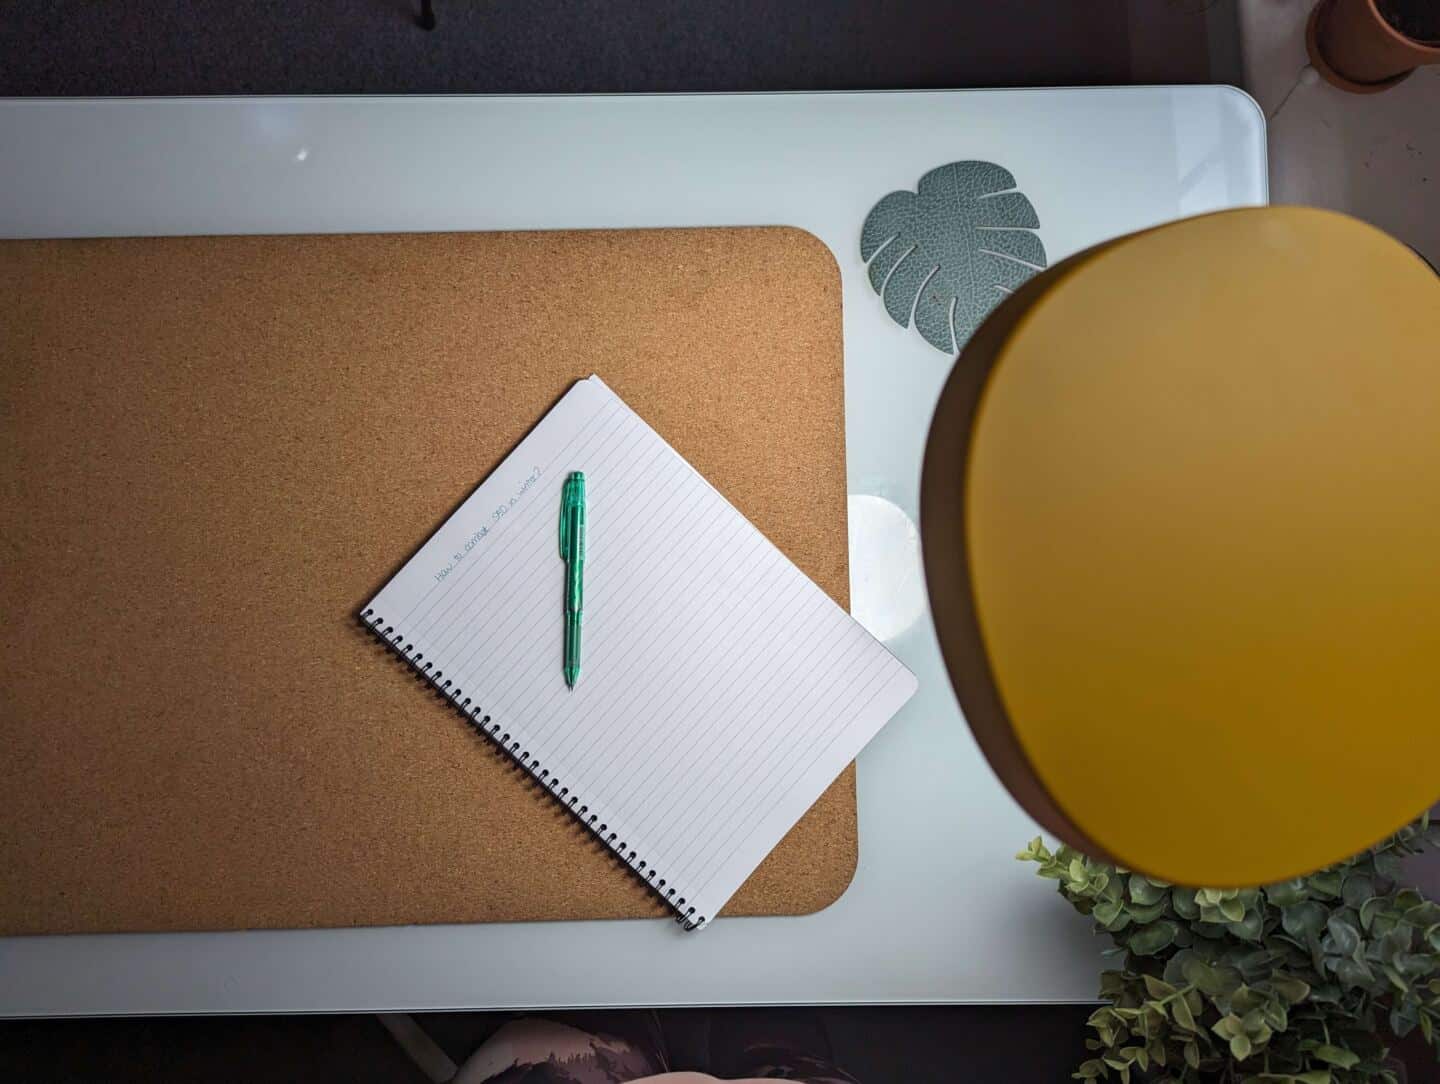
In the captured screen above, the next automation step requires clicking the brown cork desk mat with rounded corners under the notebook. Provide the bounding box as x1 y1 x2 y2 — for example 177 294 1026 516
0 229 857 934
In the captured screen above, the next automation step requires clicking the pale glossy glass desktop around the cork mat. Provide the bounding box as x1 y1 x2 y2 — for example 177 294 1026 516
0 88 1266 1015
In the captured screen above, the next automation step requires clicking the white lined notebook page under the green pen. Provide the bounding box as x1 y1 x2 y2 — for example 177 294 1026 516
363 377 916 927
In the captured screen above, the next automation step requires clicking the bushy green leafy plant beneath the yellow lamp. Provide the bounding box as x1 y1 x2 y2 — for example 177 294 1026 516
1017 818 1440 1084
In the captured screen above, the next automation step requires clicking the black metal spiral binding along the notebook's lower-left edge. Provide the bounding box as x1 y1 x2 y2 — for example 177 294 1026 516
359 609 706 930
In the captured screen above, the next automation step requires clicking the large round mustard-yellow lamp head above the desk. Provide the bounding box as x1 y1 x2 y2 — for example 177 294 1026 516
920 207 1440 885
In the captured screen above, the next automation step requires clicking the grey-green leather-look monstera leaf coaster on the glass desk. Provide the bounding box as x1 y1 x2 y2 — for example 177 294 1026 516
860 161 1045 354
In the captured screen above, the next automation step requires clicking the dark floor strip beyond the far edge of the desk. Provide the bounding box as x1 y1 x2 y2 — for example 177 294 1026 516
0 0 1240 95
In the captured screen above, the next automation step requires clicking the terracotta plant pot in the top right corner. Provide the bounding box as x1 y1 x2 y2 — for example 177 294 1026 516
1306 0 1440 94
